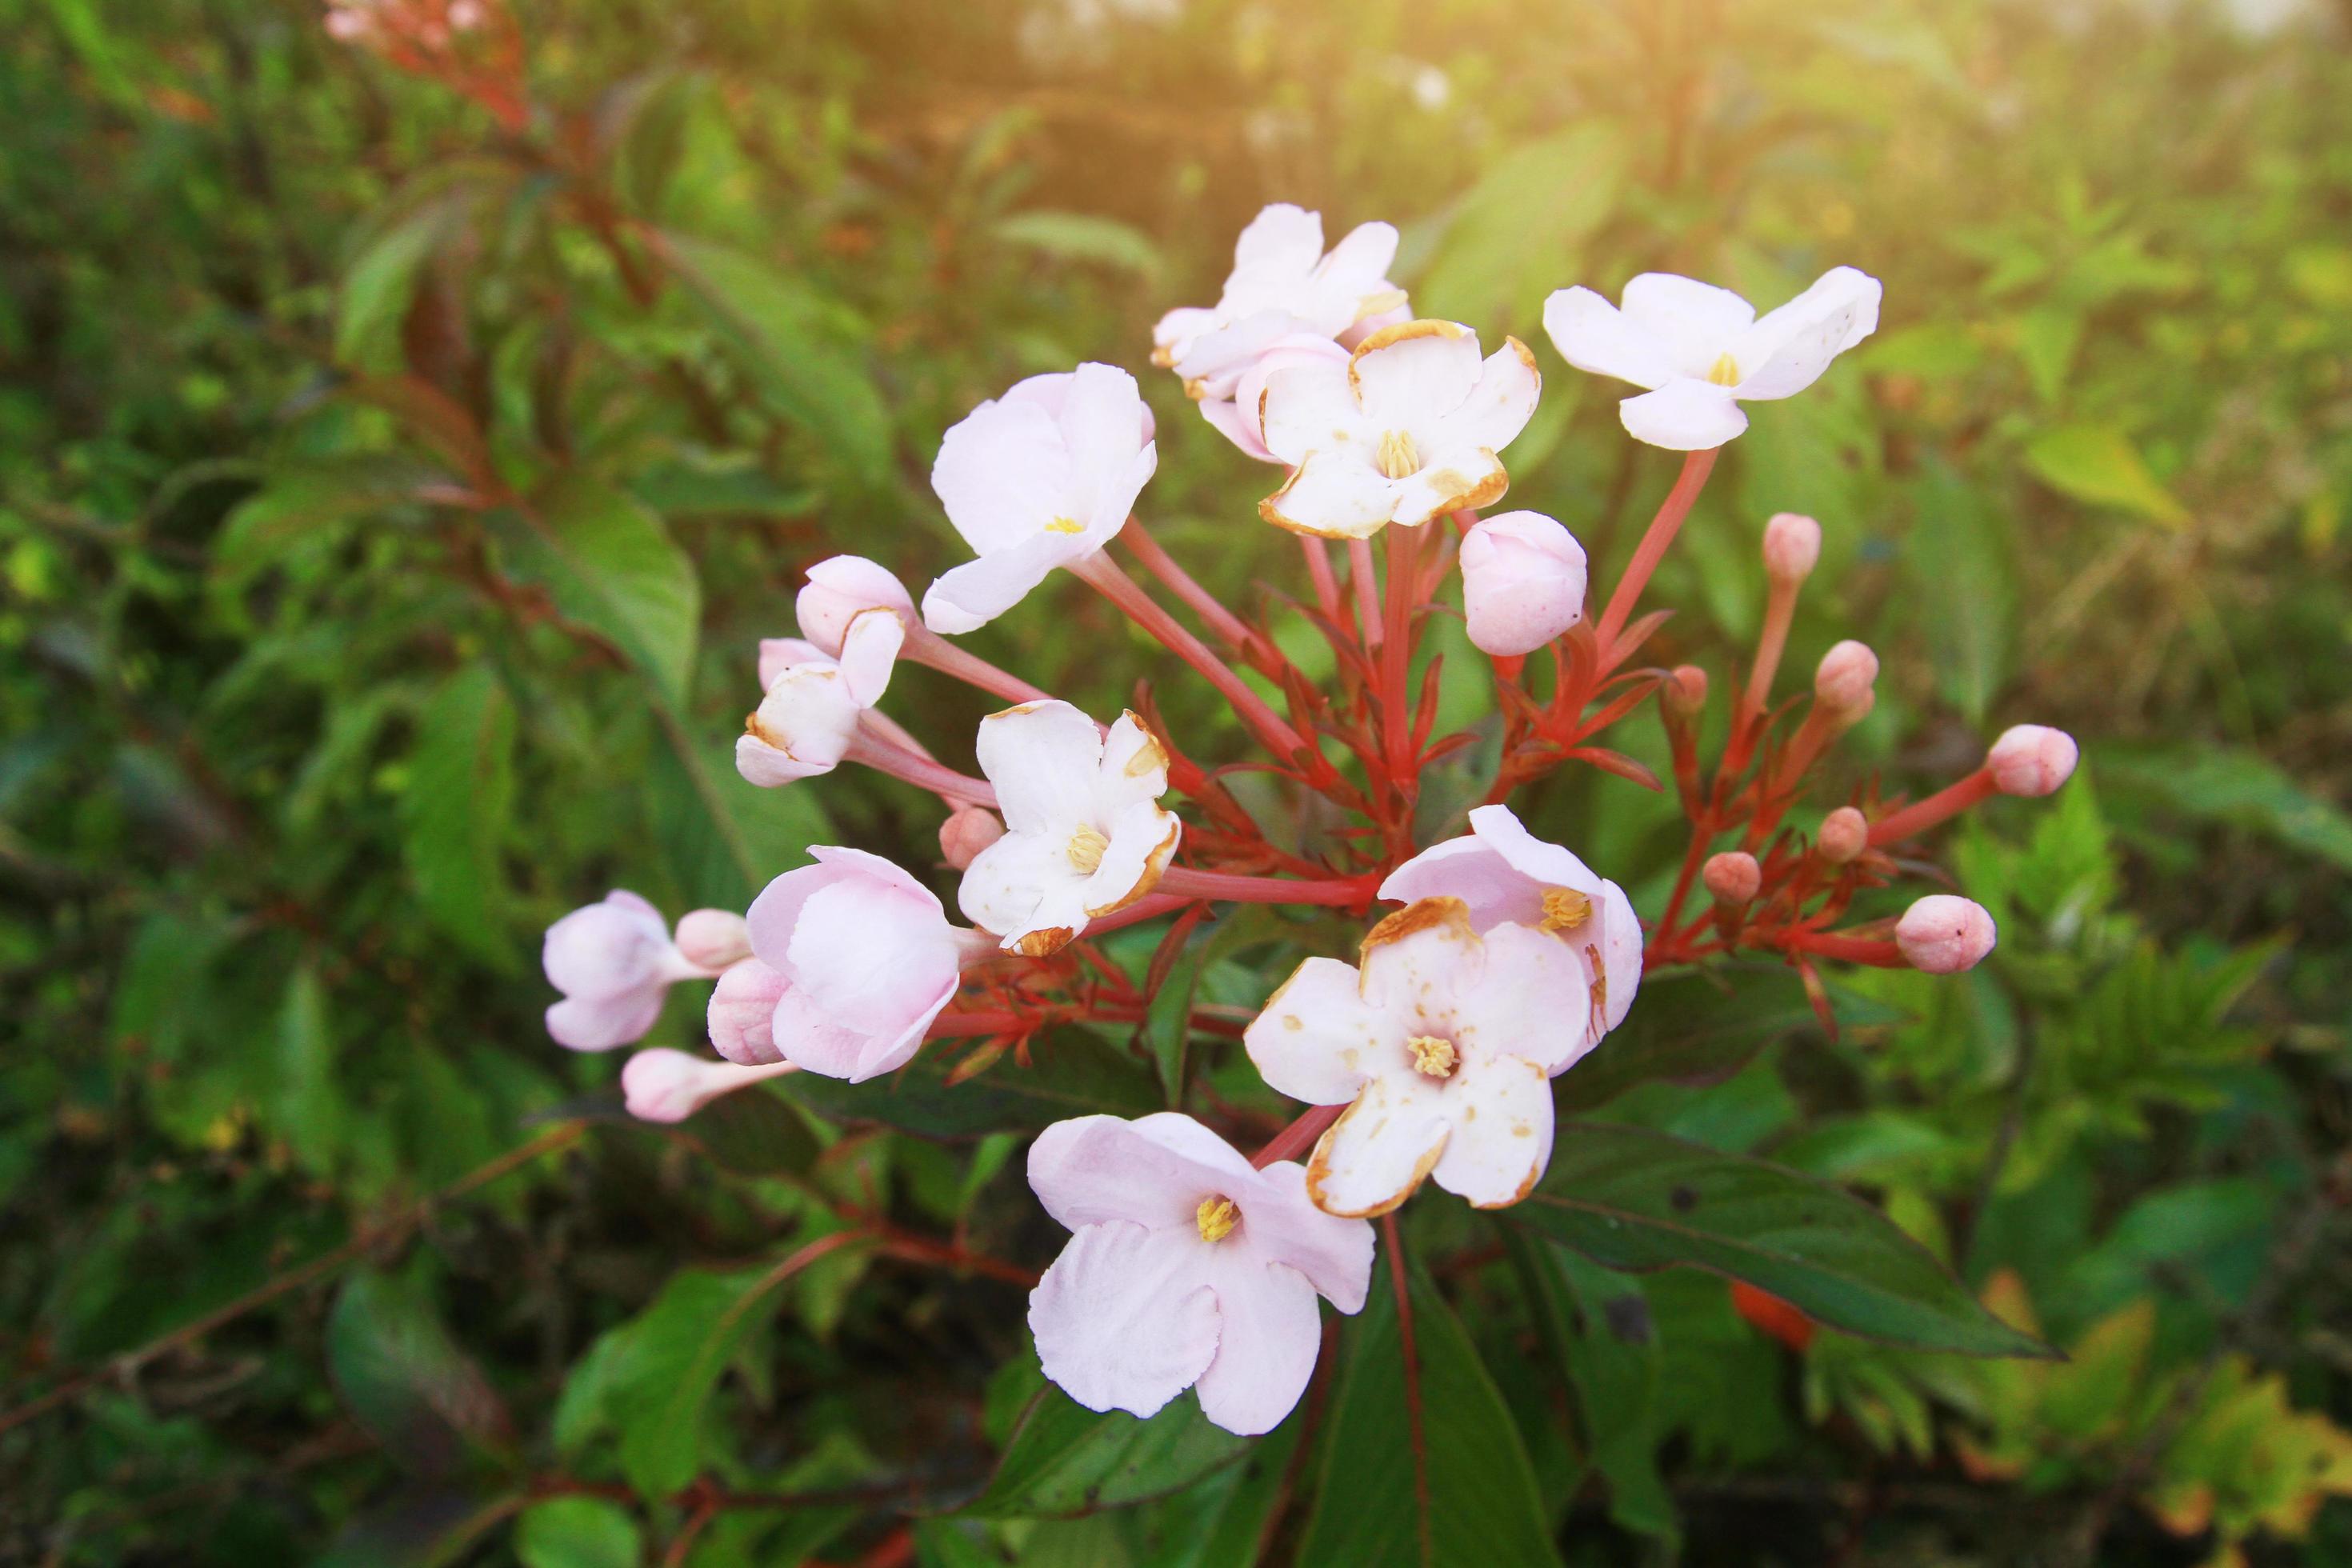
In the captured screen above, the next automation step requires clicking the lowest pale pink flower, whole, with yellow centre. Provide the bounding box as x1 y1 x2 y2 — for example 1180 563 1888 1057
1028 1112 1371 1436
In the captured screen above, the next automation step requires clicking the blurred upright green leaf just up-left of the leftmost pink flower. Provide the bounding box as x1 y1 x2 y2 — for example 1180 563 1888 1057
400 666 515 969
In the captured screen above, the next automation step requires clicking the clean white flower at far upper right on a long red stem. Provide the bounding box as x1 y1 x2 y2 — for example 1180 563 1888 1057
1543 266 1879 451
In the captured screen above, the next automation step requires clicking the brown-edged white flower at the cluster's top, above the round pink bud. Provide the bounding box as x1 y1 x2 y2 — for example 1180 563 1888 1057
1258 322 1543 538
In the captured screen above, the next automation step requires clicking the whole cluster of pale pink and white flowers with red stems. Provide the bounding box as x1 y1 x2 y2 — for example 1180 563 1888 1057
546 207 2074 1432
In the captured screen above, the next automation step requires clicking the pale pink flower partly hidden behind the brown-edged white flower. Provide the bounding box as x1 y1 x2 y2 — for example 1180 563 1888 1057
1381 803 1637 1048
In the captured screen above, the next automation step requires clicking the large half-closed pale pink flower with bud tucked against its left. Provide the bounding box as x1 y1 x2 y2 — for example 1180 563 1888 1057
734 846 995 1084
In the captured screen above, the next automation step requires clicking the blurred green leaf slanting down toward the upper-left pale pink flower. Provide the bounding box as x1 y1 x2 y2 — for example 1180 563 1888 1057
658 235 891 486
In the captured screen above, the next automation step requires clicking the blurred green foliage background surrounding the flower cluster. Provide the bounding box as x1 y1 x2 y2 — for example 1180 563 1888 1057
0 0 2352 1568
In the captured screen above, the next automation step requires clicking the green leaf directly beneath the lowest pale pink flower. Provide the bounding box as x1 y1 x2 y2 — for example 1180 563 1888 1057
962 1387 1251 1518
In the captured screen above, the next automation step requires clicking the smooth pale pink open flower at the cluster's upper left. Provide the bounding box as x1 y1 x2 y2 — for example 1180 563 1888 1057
922 364 1159 632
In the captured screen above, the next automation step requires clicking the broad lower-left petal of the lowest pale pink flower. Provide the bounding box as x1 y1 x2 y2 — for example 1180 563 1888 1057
1028 1220 1218 1415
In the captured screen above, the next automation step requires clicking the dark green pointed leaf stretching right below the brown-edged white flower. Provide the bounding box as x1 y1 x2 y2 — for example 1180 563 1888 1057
1506 1122 2051 1357
